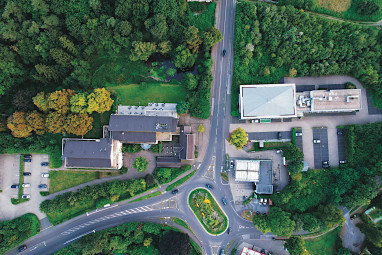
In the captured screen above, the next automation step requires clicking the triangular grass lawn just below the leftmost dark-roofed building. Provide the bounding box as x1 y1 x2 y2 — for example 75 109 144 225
49 170 119 194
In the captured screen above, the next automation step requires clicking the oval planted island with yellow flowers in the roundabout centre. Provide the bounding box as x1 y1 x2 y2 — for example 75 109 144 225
188 188 228 235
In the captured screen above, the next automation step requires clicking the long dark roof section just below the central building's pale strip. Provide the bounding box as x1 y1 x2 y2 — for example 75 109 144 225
109 114 178 132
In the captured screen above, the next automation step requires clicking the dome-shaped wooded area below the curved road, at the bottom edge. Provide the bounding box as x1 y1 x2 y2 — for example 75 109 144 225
54 222 199 255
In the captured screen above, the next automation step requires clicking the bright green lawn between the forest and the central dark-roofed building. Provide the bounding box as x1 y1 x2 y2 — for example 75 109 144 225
107 83 187 106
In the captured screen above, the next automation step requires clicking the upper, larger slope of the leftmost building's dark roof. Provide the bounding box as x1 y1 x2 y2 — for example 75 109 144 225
63 138 113 159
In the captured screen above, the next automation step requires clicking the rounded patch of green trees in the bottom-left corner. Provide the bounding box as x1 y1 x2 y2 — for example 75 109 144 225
0 213 40 254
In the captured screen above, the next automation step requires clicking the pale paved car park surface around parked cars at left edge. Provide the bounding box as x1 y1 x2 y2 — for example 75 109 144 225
0 154 48 220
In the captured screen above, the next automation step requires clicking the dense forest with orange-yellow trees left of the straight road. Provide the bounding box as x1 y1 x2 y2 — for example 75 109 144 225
0 0 222 161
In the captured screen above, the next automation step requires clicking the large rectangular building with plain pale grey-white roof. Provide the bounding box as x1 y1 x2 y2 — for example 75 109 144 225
239 84 297 119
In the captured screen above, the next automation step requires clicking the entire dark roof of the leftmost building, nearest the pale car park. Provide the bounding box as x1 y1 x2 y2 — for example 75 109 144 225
63 138 113 168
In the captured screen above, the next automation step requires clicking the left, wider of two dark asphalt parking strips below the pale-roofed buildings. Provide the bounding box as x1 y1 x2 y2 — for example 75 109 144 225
312 127 329 169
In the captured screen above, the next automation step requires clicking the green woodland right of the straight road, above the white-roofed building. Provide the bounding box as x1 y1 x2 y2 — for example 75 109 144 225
231 2 382 116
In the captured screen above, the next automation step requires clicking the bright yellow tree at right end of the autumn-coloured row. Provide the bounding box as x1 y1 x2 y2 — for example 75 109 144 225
88 88 114 114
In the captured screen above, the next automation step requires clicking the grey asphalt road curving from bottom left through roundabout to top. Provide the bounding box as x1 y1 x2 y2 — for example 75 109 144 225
9 0 261 255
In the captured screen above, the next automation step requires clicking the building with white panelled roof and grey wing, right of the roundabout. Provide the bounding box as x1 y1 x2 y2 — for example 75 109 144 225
235 159 273 194
